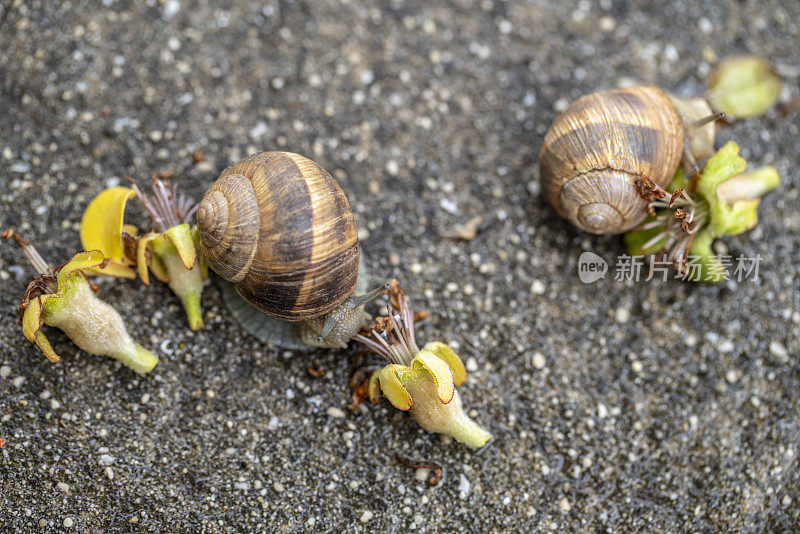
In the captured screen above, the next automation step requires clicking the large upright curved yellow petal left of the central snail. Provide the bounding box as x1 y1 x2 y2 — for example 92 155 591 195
80 186 136 263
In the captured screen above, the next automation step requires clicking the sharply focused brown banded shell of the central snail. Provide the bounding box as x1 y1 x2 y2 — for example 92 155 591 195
197 152 359 321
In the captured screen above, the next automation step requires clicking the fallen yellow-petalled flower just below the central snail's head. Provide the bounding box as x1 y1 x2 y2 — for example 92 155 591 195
353 282 491 448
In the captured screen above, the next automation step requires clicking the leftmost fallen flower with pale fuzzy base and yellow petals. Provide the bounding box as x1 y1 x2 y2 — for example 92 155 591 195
2 229 158 374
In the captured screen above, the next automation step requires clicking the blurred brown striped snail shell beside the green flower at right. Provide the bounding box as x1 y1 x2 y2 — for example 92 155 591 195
539 86 686 234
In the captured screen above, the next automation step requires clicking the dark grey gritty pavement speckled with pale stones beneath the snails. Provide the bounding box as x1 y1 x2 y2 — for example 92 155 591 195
0 0 800 532
